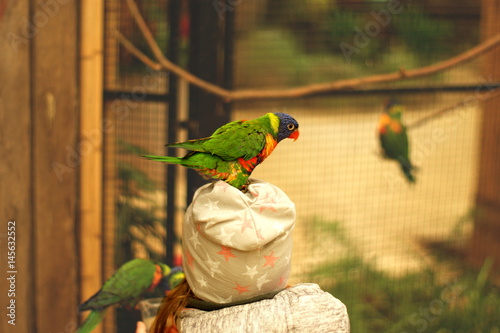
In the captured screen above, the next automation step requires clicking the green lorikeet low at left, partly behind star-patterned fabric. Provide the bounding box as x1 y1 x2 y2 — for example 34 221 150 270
77 259 180 333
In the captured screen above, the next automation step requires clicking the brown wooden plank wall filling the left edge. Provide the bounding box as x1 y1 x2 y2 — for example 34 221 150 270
0 0 102 333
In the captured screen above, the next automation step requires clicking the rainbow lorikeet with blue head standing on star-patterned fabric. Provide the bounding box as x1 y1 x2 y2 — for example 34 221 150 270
144 113 299 190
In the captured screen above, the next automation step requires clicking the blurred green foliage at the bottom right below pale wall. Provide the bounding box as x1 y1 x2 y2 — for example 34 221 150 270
309 217 500 333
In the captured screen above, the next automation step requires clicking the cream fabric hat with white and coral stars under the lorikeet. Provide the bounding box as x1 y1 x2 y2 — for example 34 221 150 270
182 179 295 304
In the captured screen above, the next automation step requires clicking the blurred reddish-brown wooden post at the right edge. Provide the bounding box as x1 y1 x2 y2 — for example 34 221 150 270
469 0 500 269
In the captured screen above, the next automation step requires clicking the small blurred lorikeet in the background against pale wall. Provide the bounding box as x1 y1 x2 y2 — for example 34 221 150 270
378 101 415 183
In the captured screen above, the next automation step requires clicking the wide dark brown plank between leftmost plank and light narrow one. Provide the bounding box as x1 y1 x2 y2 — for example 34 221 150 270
30 0 80 332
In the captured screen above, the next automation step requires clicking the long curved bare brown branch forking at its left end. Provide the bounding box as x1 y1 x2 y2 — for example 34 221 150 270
118 0 500 101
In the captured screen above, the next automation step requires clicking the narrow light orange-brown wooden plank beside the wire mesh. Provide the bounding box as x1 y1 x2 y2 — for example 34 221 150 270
79 0 106 333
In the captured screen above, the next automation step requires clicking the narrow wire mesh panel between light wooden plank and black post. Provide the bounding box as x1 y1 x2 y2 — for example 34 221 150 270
103 1 172 332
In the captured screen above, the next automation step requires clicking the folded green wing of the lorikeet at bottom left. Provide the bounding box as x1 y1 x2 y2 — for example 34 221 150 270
80 259 156 311
